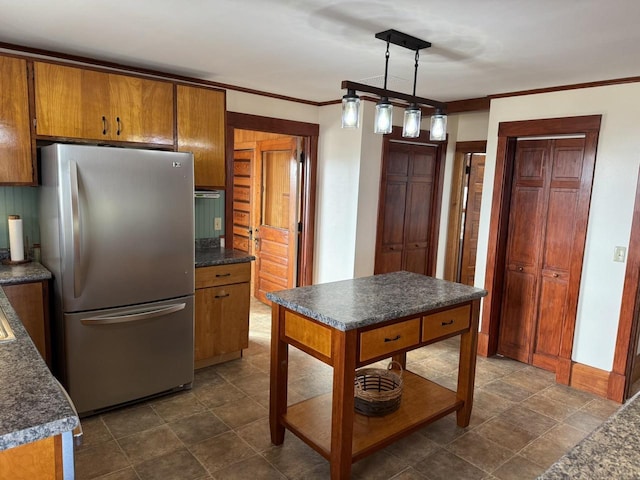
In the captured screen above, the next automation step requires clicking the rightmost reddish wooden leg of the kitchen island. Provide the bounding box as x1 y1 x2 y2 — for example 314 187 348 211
456 300 480 427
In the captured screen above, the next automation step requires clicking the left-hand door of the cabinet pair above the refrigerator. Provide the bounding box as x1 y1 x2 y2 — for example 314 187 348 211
34 62 113 140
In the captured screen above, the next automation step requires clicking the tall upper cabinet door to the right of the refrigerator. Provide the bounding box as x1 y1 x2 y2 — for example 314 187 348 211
177 85 225 188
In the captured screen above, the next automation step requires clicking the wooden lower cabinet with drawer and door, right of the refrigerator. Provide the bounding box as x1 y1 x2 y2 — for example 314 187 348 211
195 262 251 368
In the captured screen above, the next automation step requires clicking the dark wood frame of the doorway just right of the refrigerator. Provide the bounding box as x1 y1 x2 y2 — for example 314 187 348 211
225 111 320 287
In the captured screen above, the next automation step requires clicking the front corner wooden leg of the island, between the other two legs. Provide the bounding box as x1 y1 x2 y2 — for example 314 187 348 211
330 330 357 480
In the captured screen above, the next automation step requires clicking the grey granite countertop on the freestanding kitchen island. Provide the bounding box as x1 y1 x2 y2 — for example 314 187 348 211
267 272 487 331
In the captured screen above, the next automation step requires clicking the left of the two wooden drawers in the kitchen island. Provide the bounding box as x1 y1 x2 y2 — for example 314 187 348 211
359 318 420 362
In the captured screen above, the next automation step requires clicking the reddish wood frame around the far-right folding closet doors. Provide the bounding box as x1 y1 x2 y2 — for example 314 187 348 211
478 115 602 385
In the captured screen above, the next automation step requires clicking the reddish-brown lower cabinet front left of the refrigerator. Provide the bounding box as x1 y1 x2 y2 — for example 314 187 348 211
2 281 51 368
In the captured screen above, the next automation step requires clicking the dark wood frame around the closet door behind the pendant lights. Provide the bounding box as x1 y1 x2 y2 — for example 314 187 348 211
374 127 449 276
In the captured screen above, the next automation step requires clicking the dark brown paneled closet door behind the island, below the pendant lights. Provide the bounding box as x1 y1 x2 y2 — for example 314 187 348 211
374 142 438 275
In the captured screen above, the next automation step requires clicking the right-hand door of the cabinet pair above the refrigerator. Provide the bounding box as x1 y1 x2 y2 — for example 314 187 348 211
109 74 173 145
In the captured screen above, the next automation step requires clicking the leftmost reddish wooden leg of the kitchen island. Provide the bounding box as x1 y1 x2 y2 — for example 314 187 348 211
269 302 289 445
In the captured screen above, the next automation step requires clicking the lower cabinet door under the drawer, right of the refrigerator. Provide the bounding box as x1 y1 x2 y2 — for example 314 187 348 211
195 282 249 363
